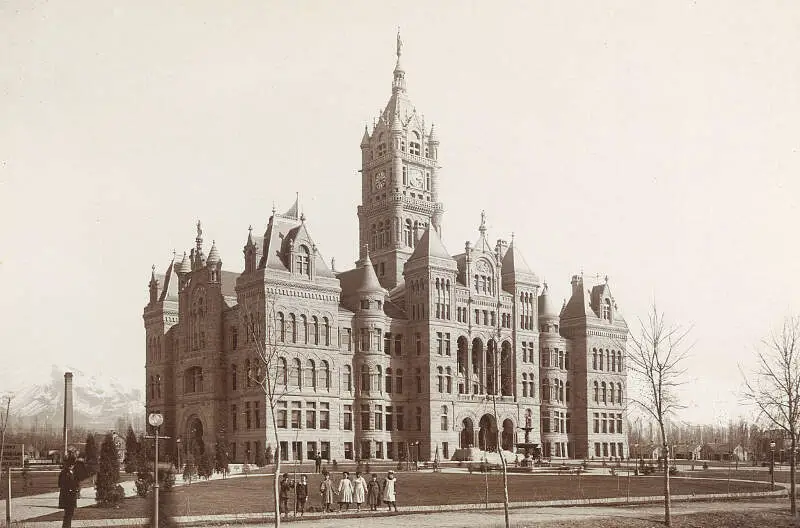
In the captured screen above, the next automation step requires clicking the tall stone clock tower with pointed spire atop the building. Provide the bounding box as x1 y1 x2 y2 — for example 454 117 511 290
358 33 444 290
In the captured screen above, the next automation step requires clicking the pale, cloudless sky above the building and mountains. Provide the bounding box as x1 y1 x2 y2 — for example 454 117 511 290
0 0 800 422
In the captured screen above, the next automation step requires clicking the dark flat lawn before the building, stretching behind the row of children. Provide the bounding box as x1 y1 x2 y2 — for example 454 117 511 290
29 472 769 520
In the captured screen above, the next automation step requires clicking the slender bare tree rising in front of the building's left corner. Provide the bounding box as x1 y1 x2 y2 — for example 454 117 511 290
242 297 296 528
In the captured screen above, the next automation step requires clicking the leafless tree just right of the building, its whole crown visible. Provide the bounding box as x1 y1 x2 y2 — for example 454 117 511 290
628 304 691 526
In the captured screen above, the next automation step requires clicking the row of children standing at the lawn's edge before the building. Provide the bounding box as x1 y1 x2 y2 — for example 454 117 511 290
279 470 397 518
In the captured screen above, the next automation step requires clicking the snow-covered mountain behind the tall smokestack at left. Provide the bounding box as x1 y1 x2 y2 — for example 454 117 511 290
11 365 145 431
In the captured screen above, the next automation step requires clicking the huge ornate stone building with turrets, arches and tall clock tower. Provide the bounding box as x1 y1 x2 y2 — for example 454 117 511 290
144 39 628 461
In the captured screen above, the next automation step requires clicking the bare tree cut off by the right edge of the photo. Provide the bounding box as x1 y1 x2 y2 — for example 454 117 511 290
742 316 800 517
